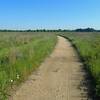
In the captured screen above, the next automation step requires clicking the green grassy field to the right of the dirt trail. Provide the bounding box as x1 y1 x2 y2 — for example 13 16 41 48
61 32 100 97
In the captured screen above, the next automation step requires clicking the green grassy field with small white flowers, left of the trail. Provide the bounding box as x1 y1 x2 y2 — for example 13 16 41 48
0 32 57 100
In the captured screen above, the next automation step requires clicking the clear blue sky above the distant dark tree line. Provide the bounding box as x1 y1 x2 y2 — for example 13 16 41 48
0 0 100 29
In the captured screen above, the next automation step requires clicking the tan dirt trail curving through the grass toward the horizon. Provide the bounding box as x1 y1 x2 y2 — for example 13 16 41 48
10 36 87 100
